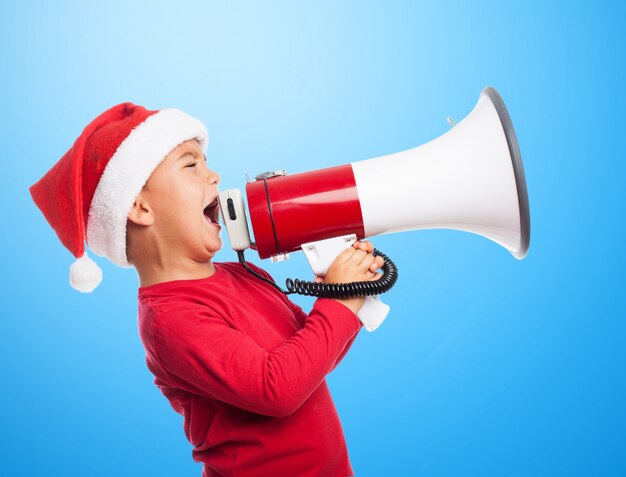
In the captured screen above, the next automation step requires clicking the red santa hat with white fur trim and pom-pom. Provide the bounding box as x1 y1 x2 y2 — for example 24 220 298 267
30 103 208 293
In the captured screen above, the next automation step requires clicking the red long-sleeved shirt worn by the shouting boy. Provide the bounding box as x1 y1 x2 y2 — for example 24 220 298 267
138 263 361 477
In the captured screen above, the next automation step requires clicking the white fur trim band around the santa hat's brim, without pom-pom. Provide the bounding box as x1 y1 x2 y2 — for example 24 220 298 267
87 109 209 268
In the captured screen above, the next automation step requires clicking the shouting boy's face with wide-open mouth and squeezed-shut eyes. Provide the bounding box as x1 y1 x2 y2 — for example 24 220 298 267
136 140 222 263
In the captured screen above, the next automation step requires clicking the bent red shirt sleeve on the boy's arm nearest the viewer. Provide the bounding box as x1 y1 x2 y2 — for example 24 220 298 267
153 299 361 416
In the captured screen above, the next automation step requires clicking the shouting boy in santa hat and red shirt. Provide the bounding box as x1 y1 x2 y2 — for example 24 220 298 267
30 103 383 477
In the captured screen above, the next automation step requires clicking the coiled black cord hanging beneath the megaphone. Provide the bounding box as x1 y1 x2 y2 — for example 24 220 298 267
237 249 398 299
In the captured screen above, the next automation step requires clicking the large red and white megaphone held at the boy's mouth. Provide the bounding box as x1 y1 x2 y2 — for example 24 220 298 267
219 87 530 329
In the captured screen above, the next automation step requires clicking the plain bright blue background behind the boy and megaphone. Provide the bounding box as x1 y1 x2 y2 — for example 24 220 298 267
0 1 626 477
